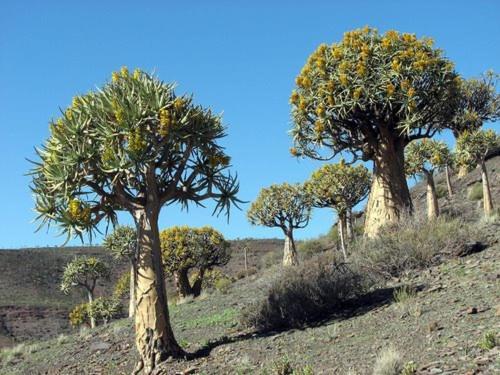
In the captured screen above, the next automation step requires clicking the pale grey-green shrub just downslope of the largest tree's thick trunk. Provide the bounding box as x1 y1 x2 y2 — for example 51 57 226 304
351 217 481 278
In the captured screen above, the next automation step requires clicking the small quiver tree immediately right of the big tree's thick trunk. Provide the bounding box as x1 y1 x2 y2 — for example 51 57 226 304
405 139 451 220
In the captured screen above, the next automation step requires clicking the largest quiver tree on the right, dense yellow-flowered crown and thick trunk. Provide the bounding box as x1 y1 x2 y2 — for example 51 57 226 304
290 27 459 236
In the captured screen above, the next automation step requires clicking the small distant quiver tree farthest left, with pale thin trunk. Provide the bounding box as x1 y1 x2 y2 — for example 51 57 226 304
61 256 110 328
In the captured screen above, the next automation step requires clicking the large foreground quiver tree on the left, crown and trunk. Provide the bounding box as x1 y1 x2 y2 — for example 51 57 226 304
31 68 239 374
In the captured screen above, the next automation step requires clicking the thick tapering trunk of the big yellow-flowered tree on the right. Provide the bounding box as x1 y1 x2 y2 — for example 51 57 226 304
364 136 413 237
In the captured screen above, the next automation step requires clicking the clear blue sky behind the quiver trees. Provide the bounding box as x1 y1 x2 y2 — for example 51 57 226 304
0 0 500 248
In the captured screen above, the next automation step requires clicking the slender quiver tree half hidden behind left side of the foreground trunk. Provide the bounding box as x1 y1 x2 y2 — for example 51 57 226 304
104 226 138 318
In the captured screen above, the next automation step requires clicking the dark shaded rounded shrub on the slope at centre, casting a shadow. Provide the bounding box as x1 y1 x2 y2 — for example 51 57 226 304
241 255 371 331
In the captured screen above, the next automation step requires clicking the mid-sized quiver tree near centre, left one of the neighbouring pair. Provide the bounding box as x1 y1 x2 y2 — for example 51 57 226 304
247 183 311 266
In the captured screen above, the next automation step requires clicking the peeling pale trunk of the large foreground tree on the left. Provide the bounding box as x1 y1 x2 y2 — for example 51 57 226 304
134 207 184 374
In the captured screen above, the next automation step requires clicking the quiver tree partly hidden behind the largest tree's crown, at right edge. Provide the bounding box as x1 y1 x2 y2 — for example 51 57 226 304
448 71 500 177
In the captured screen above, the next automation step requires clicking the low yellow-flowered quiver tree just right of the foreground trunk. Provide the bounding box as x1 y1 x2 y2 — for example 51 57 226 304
160 226 231 298
